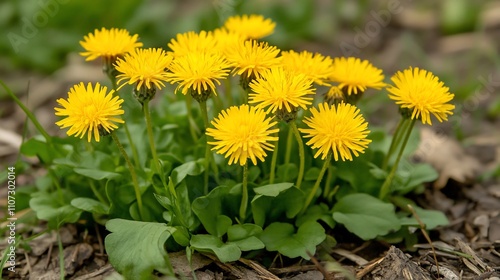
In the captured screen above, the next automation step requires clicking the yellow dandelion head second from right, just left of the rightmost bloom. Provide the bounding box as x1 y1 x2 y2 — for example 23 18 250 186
330 57 386 95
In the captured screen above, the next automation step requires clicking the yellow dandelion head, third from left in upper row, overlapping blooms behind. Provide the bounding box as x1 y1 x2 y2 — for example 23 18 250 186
166 52 231 95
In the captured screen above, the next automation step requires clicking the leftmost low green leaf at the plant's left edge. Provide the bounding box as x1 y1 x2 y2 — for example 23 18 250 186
30 189 82 229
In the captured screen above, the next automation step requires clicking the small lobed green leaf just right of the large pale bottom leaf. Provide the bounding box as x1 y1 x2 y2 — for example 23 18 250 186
191 234 241 262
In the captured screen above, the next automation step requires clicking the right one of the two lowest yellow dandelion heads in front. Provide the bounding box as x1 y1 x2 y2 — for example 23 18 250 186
299 103 371 161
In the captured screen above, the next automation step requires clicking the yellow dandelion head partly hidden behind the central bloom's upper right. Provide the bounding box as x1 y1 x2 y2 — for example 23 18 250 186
281 51 333 86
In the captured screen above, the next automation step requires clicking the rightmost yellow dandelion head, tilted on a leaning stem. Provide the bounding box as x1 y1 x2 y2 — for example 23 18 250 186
387 67 455 125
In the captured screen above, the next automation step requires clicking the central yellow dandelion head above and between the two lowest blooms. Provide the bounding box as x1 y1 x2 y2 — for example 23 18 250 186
248 67 314 113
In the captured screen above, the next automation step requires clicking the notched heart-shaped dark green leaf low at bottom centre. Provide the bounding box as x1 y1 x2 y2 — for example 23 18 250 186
260 221 326 260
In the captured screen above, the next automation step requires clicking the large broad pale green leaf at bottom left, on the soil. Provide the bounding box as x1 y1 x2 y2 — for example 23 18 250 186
104 219 175 279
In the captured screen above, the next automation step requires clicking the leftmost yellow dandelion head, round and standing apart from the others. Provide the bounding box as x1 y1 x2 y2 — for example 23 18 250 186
54 83 124 142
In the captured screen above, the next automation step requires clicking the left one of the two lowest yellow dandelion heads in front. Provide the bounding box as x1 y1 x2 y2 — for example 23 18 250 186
206 104 278 166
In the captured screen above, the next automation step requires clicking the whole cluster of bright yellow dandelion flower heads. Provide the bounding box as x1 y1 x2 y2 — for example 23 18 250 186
56 15 454 165
